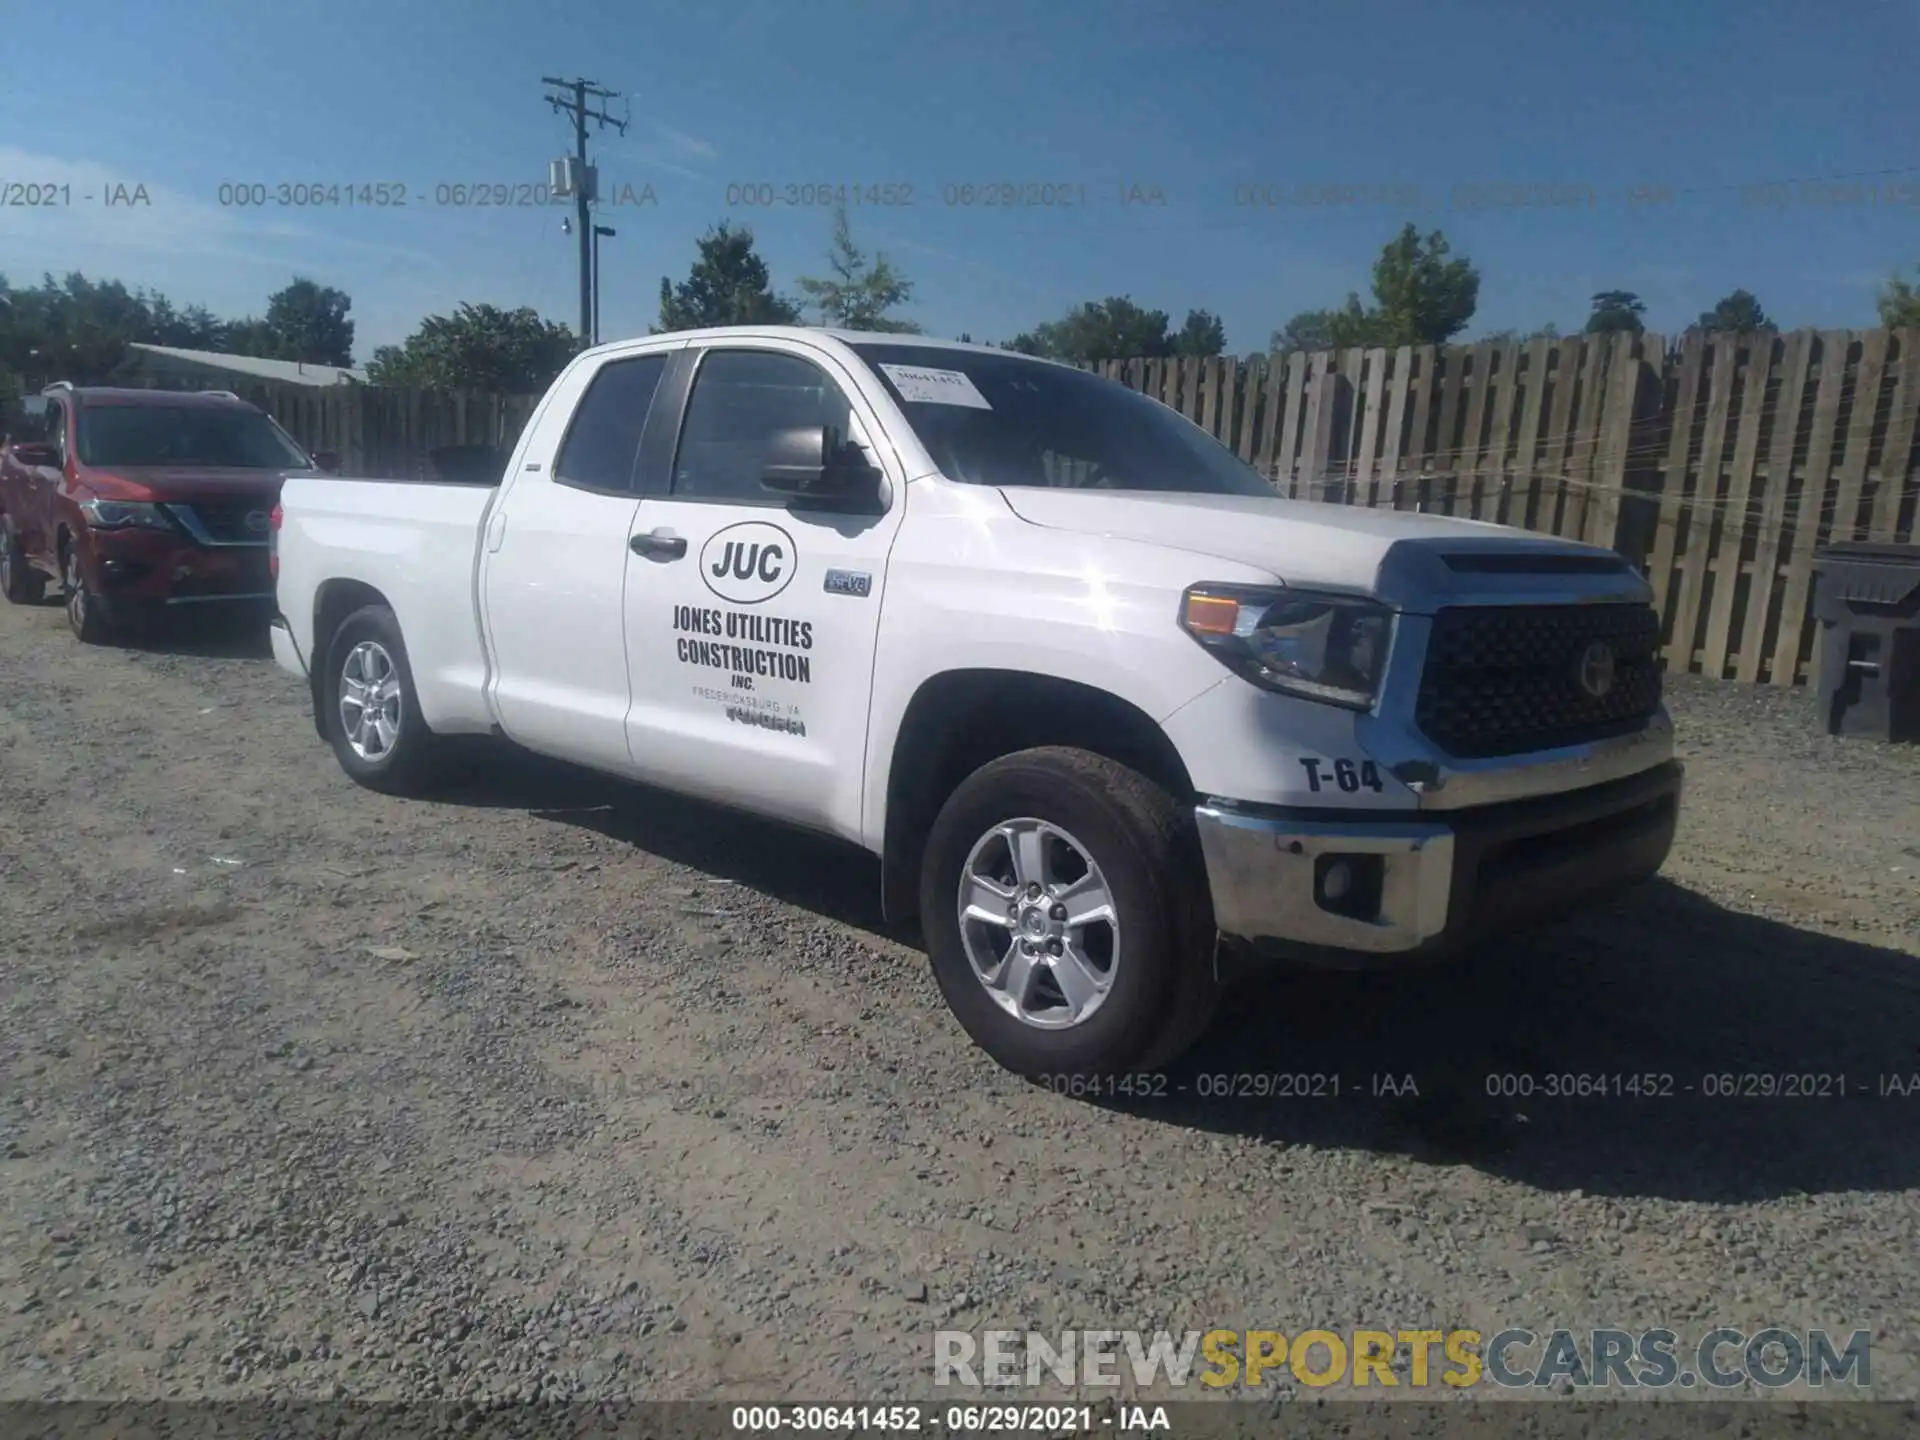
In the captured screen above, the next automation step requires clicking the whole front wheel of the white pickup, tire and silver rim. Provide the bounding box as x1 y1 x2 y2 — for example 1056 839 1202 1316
920 747 1217 1077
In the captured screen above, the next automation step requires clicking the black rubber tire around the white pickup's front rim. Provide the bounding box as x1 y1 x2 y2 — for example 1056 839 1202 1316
920 747 1219 1077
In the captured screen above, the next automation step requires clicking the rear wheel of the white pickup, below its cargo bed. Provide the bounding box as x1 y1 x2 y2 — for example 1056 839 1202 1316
323 605 445 795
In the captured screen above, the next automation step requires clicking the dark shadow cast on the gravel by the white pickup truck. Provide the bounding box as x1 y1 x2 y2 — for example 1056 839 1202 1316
445 753 1920 1202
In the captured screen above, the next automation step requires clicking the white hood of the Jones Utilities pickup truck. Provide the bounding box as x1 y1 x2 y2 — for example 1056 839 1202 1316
1000 486 1651 611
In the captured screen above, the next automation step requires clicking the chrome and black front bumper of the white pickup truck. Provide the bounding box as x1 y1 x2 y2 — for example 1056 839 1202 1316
1194 747 1682 968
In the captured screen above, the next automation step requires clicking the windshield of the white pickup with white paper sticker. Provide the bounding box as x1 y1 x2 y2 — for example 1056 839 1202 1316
854 344 1273 499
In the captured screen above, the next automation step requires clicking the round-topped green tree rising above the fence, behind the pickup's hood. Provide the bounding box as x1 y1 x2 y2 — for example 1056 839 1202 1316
1273 225 1480 351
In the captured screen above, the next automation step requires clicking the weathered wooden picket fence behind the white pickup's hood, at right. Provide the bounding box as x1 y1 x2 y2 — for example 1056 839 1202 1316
1091 328 1920 685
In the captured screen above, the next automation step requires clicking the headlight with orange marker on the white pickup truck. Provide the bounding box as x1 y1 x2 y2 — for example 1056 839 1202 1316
1181 586 1394 710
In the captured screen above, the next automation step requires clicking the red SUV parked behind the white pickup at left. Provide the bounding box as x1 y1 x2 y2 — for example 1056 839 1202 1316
0 384 330 645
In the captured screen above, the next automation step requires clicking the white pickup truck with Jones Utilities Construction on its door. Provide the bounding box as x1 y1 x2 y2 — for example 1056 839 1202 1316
273 328 1680 1075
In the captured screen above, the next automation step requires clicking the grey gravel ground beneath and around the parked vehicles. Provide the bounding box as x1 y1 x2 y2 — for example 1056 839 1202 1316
0 605 1920 1400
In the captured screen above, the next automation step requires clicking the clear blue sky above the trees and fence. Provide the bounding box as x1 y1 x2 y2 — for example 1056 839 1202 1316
0 0 1920 359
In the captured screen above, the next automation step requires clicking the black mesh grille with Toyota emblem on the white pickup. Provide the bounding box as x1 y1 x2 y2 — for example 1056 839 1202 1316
1415 605 1661 758
